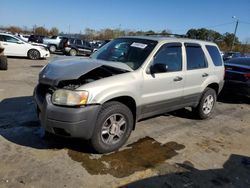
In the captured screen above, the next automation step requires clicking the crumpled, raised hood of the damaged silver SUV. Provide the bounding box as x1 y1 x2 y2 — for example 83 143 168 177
39 57 133 86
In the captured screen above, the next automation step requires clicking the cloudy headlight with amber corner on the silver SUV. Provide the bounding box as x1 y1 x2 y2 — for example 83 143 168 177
52 89 88 106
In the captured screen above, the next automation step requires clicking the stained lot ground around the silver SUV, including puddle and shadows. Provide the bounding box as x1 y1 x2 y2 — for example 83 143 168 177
0 58 250 187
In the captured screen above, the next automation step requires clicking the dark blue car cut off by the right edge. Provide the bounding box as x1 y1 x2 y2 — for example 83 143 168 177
225 57 250 95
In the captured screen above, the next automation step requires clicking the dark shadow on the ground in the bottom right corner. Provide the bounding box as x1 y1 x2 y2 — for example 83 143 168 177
122 154 250 188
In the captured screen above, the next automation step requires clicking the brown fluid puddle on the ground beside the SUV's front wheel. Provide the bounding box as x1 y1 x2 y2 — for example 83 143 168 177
68 137 185 178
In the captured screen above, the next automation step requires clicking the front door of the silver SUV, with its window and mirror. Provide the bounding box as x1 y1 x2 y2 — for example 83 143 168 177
141 43 185 117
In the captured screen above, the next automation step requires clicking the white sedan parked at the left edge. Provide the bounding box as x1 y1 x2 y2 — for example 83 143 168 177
0 33 50 59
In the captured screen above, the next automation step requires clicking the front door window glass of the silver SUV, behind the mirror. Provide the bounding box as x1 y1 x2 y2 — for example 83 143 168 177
153 43 182 72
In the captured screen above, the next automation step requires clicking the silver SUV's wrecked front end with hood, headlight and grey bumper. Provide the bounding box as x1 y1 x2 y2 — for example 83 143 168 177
34 58 133 139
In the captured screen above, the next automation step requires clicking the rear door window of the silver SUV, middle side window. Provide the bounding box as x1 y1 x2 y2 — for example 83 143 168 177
185 44 207 70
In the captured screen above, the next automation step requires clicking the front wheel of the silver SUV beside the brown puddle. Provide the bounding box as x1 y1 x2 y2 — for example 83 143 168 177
90 101 134 153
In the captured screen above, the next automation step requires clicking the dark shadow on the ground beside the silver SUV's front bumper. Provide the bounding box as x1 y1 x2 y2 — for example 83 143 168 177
0 96 93 153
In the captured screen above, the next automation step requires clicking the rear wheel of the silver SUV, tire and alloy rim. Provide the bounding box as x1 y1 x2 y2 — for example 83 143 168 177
193 88 217 119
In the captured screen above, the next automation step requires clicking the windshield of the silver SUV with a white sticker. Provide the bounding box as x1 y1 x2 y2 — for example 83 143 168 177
91 38 157 70
